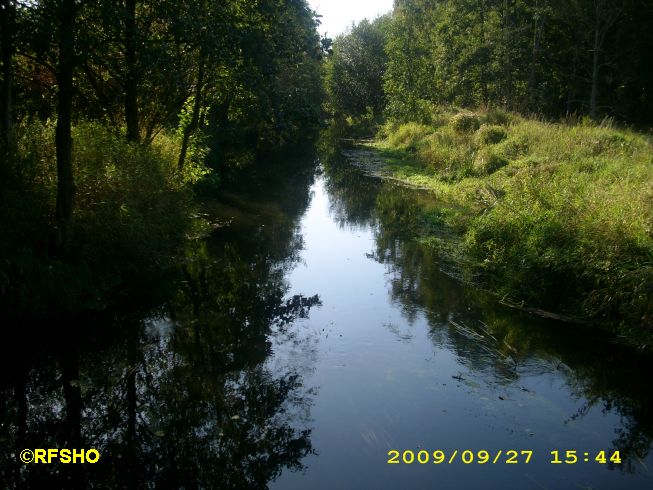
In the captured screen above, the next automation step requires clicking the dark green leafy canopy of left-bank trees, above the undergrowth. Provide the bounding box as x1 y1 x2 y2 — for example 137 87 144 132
14 0 323 151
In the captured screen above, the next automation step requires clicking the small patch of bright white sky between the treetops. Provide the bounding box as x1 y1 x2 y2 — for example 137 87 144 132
308 0 393 37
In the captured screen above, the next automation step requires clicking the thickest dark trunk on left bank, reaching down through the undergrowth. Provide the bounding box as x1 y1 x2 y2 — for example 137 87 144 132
55 0 75 255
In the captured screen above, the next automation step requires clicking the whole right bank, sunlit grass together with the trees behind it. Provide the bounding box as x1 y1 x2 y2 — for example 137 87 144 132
325 0 653 347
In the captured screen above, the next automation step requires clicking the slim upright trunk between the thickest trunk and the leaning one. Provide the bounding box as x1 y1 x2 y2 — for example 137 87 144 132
125 0 140 142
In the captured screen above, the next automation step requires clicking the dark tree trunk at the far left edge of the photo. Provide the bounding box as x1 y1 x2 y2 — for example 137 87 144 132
0 0 16 152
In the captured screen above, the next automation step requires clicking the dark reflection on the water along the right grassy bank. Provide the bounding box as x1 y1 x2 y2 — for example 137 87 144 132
323 143 653 478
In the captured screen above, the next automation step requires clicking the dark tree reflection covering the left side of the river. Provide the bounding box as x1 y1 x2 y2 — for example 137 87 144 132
0 151 320 488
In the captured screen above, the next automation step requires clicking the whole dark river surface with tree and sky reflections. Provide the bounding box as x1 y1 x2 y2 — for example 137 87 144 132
0 144 653 489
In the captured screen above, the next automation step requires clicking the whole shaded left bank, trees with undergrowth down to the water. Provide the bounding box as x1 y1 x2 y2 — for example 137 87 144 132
0 0 323 317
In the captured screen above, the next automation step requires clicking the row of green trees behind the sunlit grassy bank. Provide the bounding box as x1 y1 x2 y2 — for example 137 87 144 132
328 0 653 125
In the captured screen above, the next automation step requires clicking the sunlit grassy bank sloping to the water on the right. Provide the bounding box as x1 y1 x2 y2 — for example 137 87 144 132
366 111 653 346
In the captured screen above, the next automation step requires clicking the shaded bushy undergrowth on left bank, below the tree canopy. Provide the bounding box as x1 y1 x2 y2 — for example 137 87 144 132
0 122 210 322
